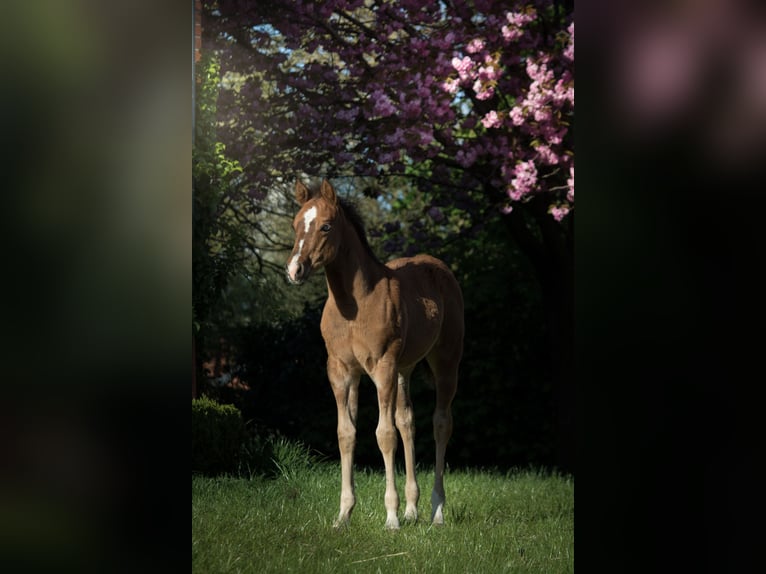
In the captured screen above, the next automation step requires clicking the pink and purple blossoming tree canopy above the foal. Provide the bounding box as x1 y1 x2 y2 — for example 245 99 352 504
206 0 574 216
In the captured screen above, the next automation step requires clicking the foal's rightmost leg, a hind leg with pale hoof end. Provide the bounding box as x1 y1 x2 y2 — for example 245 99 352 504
428 356 459 524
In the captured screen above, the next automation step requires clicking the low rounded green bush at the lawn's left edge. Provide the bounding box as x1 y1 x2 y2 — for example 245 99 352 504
192 397 246 475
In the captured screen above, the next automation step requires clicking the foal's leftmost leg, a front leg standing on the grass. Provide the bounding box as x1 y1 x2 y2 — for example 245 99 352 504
327 357 360 528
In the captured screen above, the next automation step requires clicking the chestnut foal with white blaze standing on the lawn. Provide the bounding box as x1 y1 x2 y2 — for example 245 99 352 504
286 180 465 529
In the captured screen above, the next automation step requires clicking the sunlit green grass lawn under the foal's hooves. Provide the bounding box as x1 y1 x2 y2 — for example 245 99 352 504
192 445 574 574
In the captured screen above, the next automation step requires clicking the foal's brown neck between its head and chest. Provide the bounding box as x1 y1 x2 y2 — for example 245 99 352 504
325 229 386 307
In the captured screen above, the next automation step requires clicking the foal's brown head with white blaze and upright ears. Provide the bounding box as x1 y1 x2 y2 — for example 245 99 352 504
287 180 341 285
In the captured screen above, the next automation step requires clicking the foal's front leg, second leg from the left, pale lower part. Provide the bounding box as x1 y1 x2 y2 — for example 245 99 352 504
371 359 399 529
